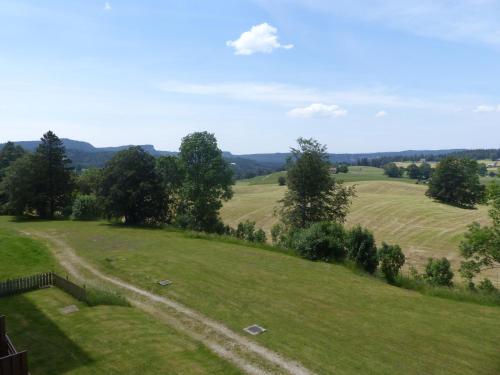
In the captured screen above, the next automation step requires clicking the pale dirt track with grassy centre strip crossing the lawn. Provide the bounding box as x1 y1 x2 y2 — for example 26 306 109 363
24 232 313 375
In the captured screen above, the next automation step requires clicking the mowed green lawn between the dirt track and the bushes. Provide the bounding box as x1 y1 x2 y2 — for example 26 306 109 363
0 219 500 375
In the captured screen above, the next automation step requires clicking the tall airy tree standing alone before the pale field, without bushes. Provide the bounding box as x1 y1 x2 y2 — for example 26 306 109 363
280 138 355 228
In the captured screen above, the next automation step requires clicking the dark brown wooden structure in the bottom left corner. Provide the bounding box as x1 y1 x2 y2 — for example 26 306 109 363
0 316 29 375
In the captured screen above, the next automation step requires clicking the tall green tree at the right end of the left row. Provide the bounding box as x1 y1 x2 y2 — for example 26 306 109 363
179 132 234 232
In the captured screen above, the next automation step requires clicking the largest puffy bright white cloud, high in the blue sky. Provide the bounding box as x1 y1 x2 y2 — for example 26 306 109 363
226 22 293 55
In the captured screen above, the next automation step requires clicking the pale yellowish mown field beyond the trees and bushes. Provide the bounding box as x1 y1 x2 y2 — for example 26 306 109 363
222 180 496 281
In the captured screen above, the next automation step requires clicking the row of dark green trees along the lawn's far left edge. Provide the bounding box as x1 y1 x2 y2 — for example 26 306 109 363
0 131 234 232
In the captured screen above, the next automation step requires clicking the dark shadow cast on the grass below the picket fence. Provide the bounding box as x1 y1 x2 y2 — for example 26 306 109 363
0 295 93 375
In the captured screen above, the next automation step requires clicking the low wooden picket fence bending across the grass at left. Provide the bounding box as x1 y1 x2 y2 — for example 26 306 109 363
0 272 87 304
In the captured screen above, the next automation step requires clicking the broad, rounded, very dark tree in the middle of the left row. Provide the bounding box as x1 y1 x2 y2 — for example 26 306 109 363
99 147 166 224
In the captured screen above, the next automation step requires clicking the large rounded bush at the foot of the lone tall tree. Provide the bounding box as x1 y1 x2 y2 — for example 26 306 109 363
292 222 347 262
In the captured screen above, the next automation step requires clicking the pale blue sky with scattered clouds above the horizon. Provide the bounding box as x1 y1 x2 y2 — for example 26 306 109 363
0 0 500 153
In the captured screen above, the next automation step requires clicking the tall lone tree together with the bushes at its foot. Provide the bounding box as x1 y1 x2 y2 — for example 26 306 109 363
271 138 405 283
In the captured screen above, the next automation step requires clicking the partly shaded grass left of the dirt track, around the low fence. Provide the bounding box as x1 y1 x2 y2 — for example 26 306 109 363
0 229 239 375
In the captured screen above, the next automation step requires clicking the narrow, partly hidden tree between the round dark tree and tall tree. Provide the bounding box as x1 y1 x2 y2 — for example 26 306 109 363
156 156 184 223
